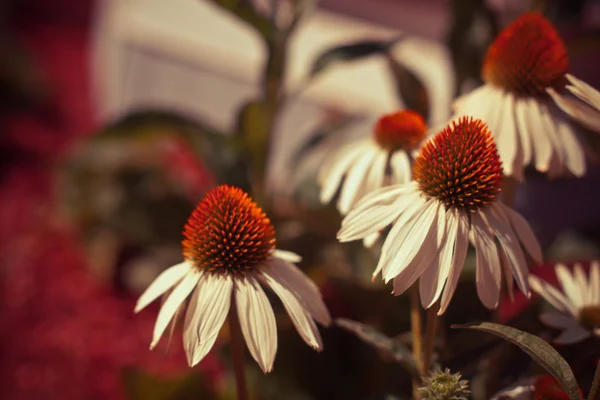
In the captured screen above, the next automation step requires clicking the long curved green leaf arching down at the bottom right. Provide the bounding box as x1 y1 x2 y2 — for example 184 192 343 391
452 322 581 400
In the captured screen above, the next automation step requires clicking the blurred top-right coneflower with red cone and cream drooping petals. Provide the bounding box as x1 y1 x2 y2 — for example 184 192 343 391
454 13 586 180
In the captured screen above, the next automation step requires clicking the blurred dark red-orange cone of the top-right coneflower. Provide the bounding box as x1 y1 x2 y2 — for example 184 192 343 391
481 13 569 96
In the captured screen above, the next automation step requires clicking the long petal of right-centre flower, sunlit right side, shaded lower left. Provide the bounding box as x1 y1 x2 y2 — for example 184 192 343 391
419 210 458 309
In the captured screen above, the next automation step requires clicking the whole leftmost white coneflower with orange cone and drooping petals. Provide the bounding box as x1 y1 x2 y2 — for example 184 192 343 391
135 185 331 373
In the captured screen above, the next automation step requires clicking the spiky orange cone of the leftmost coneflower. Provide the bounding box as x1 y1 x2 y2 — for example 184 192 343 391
183 185 275 274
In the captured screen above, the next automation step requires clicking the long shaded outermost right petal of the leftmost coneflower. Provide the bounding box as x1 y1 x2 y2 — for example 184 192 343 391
262 259 331 326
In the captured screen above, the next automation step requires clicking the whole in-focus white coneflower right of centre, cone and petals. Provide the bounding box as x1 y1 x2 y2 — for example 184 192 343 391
338 117 541 314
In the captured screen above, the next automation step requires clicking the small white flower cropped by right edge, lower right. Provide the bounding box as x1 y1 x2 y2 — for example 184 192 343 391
529 262 600 344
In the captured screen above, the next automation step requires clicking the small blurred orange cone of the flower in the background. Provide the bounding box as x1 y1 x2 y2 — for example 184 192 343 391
373 110 427 151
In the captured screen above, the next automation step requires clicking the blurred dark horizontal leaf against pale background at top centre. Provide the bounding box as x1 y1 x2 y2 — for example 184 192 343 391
310 36 401 78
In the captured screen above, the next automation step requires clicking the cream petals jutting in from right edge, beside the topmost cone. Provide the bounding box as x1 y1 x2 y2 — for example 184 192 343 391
547 74 600 132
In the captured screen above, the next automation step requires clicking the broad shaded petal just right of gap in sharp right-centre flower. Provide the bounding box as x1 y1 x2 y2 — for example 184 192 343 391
471 212 502 309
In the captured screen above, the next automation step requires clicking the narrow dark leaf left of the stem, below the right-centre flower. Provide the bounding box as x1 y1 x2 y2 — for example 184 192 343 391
335 318 420 377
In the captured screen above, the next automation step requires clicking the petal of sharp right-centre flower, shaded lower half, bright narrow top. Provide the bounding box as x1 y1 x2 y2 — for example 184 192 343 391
394 205 446 295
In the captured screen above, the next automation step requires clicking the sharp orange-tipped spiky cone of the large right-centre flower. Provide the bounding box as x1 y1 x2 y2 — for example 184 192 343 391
413 117 503 212
